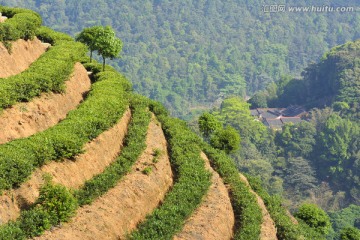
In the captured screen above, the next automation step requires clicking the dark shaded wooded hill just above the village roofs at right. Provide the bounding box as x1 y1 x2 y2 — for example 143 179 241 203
268 40 360 121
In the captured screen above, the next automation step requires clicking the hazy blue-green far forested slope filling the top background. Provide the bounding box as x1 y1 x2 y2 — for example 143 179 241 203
0 0 360 119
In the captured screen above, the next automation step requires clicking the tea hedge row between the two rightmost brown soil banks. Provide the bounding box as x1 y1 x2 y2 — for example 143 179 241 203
202 144 262 240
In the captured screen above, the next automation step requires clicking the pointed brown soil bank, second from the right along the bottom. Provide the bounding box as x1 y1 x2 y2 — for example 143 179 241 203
174 153 235 240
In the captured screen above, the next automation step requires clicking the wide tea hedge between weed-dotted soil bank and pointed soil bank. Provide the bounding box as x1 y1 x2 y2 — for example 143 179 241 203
130 102 210 239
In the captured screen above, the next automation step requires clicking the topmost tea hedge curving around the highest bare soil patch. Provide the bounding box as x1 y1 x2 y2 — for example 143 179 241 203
0 6 87 110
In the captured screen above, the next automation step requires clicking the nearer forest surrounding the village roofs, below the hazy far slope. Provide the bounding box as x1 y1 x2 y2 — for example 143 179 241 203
193 38 360 239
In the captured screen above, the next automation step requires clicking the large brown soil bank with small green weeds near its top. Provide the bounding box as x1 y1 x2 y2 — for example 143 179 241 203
36 116 173 240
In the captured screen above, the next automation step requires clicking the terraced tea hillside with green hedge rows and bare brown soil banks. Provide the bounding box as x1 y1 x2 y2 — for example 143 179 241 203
0 7 310 240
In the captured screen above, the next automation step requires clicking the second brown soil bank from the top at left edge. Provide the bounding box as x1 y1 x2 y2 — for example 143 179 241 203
0 62 91 144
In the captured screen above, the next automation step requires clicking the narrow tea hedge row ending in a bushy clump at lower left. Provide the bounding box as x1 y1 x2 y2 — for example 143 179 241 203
0 94 147 240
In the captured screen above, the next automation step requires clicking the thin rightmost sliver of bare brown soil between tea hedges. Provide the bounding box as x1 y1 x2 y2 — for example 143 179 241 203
239 173 278 240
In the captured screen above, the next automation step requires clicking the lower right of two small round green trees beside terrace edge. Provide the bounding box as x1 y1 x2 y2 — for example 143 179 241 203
210 126 240 154
